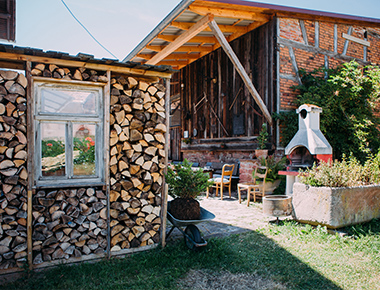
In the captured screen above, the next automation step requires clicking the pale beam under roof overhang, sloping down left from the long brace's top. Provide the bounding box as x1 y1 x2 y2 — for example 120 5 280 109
146 15 214 65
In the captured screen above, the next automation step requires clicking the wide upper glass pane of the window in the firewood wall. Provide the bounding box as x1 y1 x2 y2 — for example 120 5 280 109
41 88 97 115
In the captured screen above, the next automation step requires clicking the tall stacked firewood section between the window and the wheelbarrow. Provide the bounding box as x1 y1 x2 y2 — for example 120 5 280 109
110 76 166 252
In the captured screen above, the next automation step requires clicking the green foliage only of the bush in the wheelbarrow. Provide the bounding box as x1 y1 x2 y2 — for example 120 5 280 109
165 159 213 198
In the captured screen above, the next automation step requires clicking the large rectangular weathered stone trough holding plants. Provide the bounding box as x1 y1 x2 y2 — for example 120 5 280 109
293 182 380 229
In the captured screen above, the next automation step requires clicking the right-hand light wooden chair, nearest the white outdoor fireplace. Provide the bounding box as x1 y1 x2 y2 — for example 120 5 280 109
237 166 268 206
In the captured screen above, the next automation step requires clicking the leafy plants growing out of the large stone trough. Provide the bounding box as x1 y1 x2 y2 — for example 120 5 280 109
300 151 380 187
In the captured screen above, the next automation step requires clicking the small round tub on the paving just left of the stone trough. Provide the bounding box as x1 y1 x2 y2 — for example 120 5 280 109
263 195 292 217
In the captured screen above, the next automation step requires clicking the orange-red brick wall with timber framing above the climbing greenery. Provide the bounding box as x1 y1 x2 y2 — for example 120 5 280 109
277 18 380 111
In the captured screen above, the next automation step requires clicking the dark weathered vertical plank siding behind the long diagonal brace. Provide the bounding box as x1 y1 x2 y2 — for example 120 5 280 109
172 21 276 139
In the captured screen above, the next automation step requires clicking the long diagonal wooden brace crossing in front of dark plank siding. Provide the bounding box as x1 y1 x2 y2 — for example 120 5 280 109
209 20 273 125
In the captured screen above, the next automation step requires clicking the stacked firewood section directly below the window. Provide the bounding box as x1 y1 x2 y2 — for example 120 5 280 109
32 188 107 264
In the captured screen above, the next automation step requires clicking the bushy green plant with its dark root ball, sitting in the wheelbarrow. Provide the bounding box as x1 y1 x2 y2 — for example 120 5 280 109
165 159 212 220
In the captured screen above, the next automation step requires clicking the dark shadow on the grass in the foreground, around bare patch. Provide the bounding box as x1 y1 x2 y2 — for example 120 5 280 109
0 224 341 290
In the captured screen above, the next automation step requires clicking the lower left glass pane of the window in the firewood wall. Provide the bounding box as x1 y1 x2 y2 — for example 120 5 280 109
41 122 66 176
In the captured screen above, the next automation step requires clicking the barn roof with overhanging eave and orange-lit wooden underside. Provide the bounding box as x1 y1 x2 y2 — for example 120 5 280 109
123 0 380 69
